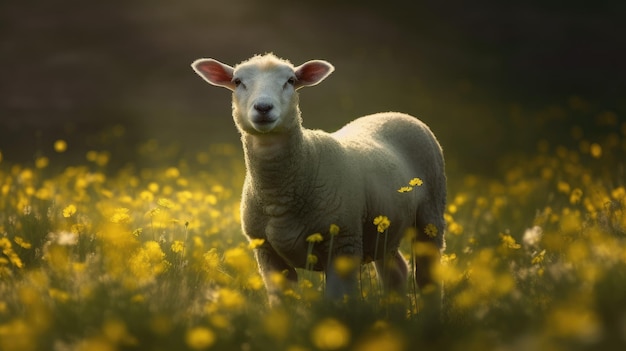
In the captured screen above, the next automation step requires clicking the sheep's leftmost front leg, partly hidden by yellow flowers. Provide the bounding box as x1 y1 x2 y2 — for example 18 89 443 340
255 244 298 307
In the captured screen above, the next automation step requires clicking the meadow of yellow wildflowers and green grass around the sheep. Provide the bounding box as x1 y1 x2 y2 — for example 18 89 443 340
0 108 626 351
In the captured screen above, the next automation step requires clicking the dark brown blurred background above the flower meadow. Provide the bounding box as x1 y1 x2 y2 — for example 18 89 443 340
0 0 626 172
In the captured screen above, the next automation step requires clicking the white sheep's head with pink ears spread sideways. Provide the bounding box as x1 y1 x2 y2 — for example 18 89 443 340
191 54 334 134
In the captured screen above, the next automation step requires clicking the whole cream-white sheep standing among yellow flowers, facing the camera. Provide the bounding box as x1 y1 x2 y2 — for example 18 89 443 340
192 54 446 311
